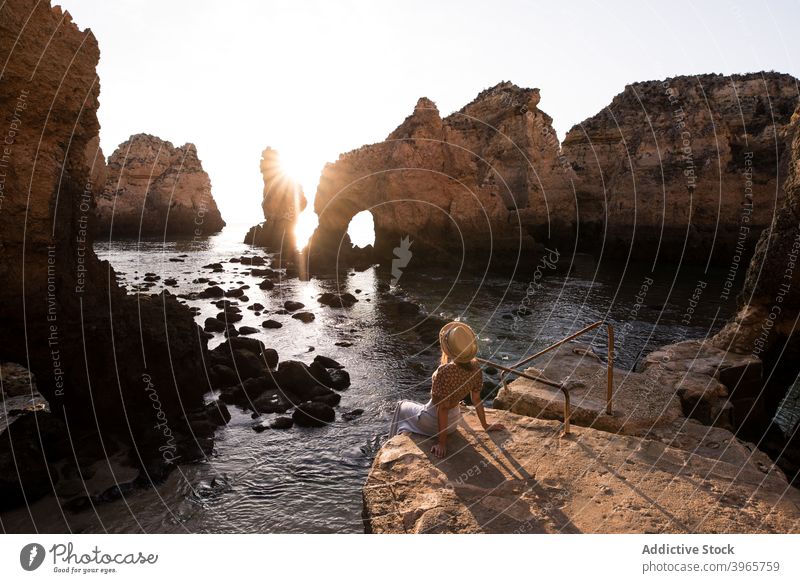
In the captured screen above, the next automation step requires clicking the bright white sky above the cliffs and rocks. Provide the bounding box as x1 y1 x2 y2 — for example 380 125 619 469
56 0 800 223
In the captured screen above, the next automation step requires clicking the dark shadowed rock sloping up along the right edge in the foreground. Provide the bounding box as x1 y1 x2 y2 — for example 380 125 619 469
643 105 800 479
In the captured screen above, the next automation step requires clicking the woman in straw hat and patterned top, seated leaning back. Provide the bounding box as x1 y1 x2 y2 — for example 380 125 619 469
389 322 505 458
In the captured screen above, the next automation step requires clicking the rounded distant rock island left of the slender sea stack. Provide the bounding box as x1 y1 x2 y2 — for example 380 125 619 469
96 134 225 236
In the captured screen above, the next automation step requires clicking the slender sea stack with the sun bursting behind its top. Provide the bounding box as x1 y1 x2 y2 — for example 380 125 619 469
244 148 306 253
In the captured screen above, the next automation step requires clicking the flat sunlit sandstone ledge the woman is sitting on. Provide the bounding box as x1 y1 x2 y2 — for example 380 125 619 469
363 410 800 534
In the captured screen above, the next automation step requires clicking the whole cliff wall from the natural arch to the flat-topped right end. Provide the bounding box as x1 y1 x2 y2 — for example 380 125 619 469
255 73 798 264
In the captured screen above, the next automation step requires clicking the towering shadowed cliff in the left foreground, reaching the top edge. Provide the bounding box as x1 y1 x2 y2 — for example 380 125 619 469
0 0 225 502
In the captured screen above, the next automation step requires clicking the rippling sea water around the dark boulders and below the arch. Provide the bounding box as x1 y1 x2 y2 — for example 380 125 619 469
3 225 735 533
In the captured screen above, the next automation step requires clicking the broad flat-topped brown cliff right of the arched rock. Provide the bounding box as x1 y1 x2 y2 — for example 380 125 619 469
562 73 798 262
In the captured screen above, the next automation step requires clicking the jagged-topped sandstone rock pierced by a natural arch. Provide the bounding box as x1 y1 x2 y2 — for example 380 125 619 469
312 83 570 262
